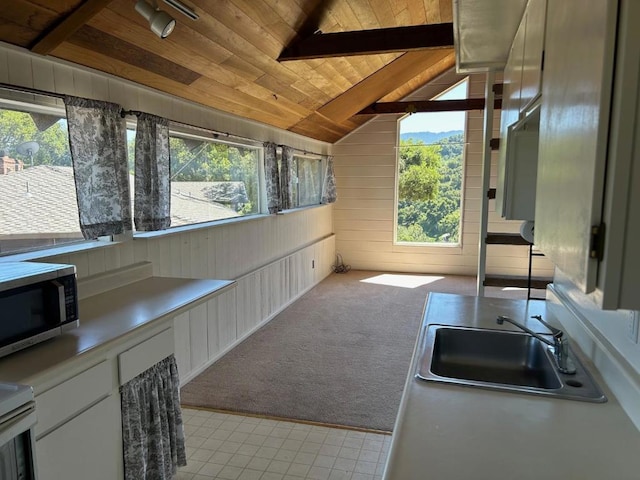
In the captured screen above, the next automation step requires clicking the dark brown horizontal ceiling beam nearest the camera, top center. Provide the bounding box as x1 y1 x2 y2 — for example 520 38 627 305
278 23 453 62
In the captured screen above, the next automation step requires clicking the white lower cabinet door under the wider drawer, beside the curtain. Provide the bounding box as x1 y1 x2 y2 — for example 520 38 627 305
36 394 124 480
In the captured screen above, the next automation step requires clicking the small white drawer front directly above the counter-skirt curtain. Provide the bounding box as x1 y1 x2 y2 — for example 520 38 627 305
118 328 174 385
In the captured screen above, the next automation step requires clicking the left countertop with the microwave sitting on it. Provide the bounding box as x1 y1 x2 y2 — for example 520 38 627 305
0 277 234 385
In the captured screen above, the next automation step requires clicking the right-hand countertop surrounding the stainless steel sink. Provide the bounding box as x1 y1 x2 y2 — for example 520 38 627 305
384 293 640 480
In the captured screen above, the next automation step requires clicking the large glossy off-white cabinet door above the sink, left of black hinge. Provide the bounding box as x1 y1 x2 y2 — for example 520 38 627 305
535 0 617 293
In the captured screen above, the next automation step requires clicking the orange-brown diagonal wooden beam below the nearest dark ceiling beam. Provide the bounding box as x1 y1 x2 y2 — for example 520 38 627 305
318 48 455 123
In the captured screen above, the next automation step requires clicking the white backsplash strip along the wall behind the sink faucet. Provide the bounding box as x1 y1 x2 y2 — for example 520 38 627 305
547 284 640 430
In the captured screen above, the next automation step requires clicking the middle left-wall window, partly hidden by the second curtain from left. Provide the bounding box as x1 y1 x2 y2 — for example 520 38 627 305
127 129 262 227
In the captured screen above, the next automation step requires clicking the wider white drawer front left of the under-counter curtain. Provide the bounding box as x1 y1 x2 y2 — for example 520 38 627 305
35 360 112 437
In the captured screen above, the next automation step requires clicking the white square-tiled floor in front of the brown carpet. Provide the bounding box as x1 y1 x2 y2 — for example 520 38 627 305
174 408 391 480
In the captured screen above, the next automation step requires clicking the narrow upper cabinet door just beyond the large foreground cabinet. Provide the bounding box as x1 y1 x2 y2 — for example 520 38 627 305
520 0 547 111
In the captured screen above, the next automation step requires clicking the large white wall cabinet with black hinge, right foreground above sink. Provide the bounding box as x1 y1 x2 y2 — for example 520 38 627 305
536 0 640 310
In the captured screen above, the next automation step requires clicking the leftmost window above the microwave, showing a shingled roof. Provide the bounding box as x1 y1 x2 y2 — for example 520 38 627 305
0 93 84 255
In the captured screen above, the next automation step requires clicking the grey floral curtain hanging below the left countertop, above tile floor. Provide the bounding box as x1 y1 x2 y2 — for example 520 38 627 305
120 355 187 480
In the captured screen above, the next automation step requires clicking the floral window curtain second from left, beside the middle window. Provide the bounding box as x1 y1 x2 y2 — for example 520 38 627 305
133 113 171 231
